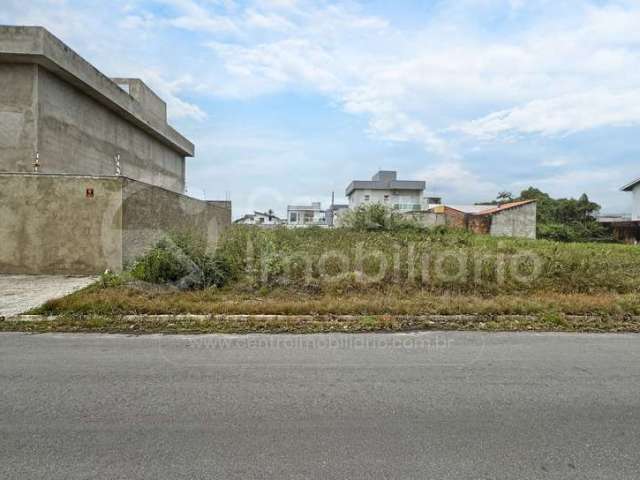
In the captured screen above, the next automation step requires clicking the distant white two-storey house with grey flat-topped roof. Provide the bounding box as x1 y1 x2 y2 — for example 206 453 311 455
345 170 425 212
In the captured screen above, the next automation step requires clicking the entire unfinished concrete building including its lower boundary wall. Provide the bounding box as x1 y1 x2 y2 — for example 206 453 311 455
0 27 231 274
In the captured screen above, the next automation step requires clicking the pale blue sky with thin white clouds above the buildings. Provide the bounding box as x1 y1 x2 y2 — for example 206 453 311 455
0 0 640 214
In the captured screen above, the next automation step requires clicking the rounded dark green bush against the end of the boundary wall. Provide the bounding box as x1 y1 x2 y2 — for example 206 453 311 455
130 233 230 289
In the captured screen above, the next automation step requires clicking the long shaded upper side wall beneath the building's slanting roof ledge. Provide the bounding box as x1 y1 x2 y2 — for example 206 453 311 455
38 67 185 192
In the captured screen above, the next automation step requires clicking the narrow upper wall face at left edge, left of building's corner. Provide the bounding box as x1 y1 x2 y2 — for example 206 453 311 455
0 63 38 172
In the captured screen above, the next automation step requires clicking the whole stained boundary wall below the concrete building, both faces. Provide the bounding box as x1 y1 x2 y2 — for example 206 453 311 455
0 174 231 275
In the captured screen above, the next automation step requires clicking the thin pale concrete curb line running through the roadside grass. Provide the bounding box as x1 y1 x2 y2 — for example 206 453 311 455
5 314 640 323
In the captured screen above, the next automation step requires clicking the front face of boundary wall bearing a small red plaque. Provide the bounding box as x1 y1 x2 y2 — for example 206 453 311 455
0 174 122 274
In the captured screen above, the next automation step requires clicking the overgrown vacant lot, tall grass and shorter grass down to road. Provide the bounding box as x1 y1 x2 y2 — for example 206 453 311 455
11 228 640 332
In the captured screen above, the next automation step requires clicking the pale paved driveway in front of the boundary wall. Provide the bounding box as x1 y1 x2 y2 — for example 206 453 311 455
0 274 98 317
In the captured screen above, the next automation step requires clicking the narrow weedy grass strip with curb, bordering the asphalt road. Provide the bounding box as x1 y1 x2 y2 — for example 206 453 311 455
0 313 640 334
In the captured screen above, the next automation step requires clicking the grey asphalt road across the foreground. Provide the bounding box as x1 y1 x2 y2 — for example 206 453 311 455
0 332 640 480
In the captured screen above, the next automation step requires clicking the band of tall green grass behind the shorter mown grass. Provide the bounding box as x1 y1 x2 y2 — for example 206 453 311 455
218 226 640 295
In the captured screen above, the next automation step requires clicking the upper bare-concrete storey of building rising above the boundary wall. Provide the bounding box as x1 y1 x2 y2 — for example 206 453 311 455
0 27 194 193
